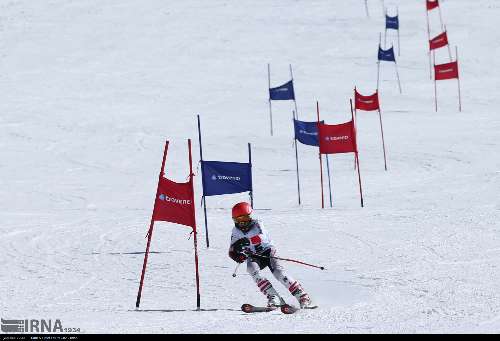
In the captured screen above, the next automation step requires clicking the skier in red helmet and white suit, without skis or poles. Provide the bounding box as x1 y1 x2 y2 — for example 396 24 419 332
229 202 311 308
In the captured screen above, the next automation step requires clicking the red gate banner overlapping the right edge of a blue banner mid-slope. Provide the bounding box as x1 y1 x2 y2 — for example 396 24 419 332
318 121 358 154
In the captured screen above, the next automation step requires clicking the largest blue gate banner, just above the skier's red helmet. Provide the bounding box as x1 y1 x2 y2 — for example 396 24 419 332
201 161 252 196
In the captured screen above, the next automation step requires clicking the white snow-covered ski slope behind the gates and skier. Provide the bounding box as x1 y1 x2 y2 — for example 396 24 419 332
0 0 500 333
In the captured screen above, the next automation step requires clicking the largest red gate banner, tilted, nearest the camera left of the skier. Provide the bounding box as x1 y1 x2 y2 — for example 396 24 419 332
153 177 196 229
